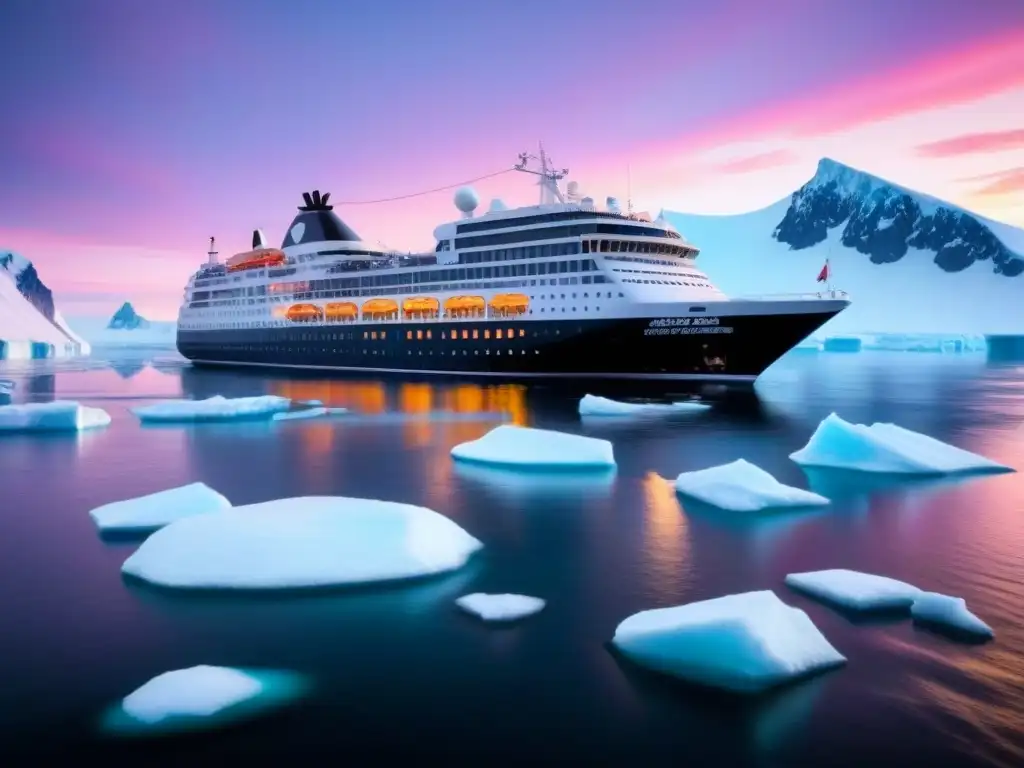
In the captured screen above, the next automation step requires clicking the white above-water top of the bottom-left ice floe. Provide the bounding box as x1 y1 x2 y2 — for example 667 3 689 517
121 665 263 723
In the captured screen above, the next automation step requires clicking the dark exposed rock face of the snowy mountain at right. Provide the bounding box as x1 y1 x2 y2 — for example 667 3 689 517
772 158 1024 278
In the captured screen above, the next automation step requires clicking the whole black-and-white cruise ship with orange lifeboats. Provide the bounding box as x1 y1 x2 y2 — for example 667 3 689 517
177 147 849 383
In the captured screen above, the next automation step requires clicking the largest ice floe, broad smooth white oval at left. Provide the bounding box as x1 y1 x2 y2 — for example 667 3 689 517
122 497 483 589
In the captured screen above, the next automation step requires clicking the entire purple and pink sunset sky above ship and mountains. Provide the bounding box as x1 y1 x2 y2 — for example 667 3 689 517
0 0 1024 319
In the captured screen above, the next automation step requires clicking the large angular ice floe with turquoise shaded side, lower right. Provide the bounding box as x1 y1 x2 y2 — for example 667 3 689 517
611 591 846 693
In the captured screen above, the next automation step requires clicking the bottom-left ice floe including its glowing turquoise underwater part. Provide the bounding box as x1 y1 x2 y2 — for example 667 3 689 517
105 665 306 734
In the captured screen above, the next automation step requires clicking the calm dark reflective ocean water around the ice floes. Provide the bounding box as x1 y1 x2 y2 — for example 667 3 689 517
0 352 1024 767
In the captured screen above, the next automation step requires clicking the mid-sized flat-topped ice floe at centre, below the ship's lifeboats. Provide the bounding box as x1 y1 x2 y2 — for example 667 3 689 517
452 424 615 469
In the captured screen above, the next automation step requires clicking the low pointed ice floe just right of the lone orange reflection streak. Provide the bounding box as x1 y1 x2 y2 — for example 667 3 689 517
676 459 829 512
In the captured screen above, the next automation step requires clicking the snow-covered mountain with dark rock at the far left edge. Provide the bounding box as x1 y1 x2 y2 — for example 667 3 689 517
0 251 89 358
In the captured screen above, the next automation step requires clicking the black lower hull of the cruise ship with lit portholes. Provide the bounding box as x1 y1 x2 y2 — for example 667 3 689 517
177 303 843 383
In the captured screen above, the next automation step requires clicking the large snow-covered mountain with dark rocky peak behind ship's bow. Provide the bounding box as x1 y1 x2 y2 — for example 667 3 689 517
664 159 1024 334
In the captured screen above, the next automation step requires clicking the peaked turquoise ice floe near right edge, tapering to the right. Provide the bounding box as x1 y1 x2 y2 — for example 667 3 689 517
790 414 1014 475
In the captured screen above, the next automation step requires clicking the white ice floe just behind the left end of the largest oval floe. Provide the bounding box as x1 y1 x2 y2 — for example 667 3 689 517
89 482 231 532
